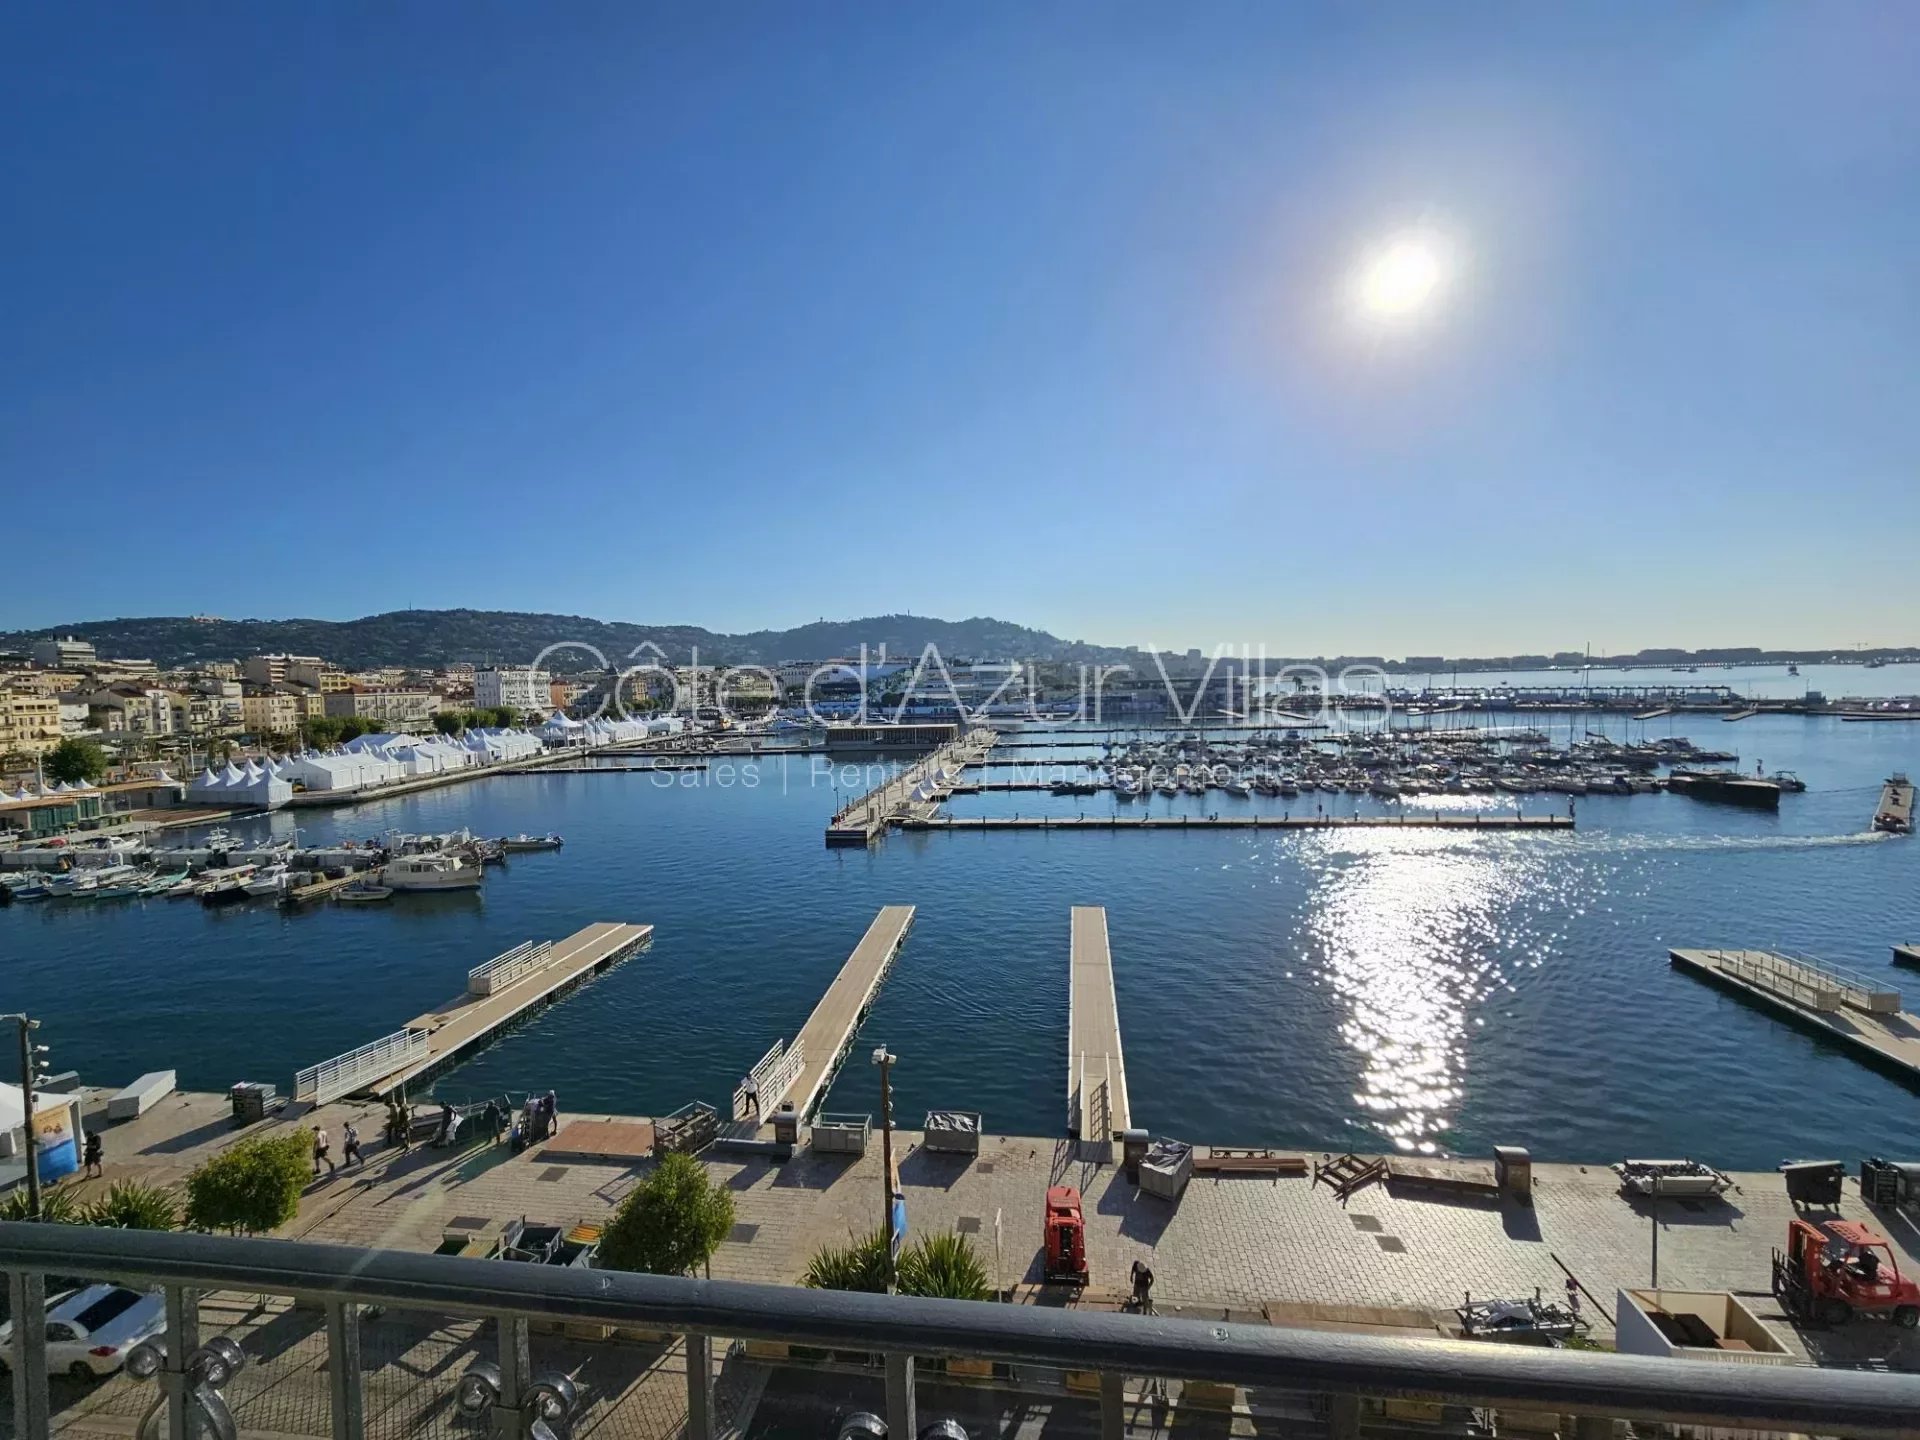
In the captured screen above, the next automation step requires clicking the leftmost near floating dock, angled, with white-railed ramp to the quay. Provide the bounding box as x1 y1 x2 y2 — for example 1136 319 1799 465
294 920 653 1104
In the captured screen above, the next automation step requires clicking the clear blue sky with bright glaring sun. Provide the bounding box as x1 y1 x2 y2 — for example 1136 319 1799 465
0 0 1920 655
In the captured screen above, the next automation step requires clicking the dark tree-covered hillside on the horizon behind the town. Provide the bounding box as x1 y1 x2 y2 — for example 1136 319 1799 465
0 611 1119 670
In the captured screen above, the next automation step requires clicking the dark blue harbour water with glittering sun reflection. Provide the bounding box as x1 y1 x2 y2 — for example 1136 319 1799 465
0 666 1920 1169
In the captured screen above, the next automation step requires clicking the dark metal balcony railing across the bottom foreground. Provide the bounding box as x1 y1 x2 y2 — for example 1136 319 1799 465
0 1223 1920 1440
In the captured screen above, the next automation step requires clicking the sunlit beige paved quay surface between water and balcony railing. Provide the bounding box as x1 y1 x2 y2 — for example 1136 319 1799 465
26 1092 1920 1440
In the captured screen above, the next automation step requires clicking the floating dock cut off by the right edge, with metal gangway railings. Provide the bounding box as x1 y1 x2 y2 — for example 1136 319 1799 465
1667 950 1920 1083
